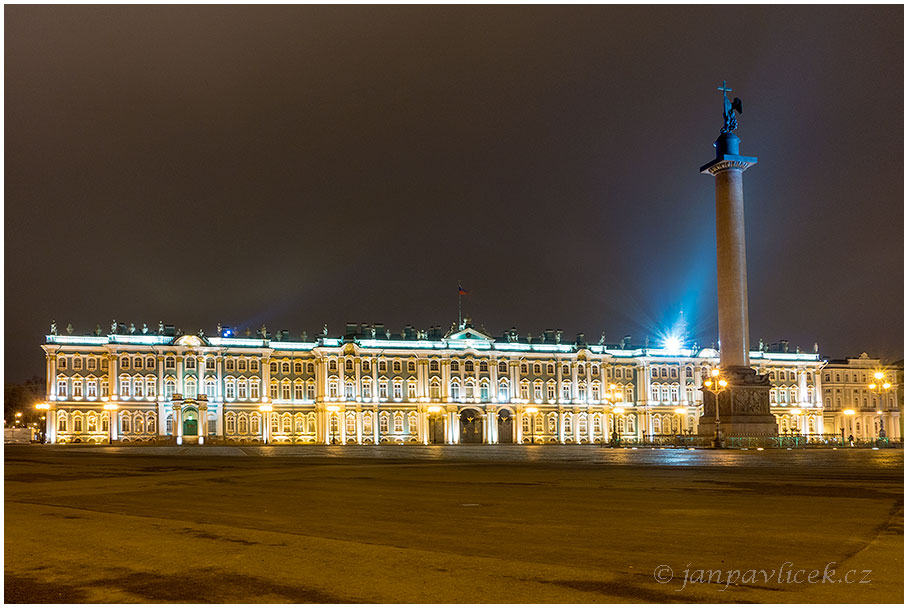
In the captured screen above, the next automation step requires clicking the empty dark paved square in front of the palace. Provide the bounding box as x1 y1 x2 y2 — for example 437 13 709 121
4 445 904 603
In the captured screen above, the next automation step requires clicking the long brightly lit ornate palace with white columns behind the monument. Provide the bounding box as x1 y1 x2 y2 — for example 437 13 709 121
37 323 860 444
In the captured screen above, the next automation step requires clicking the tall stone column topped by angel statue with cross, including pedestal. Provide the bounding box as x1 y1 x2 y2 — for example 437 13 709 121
698 80 778 447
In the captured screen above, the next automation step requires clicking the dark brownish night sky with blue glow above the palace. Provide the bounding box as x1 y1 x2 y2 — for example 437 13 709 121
4 6 904 381
